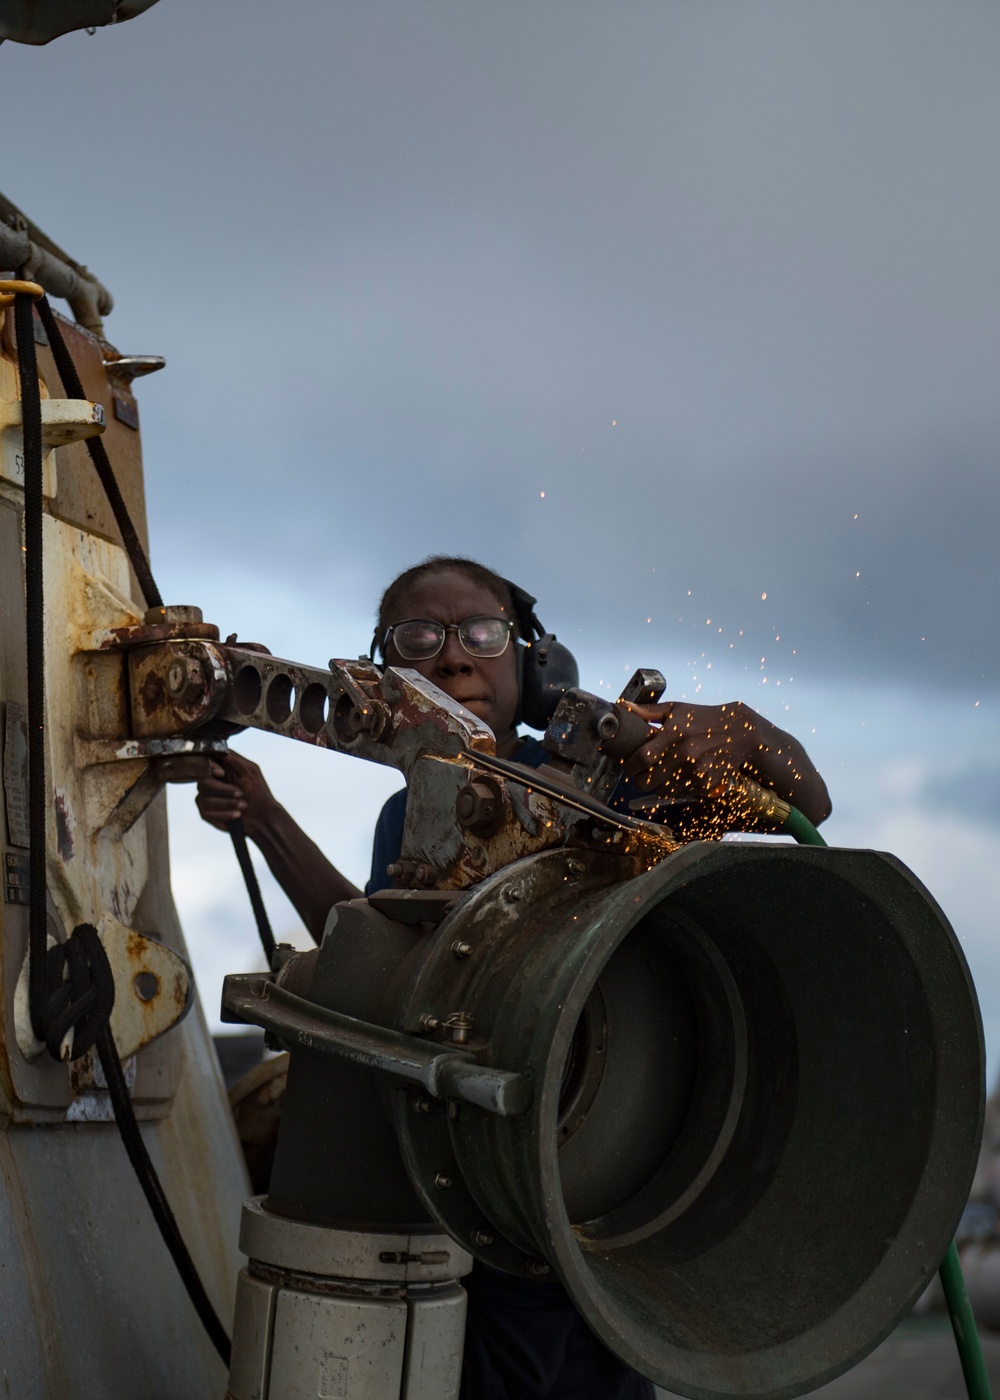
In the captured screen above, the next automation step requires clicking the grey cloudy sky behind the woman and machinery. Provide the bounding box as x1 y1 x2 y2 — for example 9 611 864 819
0 0 1000 1050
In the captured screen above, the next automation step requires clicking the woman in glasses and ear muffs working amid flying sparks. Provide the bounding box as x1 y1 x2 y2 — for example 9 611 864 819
197 556 829 1400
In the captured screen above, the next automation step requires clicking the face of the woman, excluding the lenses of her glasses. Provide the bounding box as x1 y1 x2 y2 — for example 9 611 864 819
385 571 517 756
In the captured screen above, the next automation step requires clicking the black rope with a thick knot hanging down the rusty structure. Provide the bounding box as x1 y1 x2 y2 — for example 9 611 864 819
14 293 231 1366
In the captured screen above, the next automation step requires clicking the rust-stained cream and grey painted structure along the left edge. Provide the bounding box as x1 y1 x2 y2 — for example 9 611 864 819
0 289 248 1400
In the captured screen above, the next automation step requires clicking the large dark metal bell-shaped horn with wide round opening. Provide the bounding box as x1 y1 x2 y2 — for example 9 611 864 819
259 843 985 1400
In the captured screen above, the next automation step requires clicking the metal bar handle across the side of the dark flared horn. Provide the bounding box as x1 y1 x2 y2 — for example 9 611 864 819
223 973 531 1117
